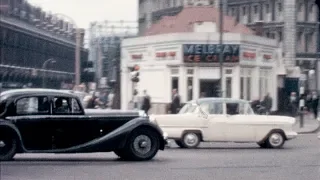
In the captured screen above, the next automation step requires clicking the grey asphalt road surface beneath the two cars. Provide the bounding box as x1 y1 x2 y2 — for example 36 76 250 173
0 134 320 180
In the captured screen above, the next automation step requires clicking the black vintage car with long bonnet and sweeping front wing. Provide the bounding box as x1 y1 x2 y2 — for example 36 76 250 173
0 89 166 161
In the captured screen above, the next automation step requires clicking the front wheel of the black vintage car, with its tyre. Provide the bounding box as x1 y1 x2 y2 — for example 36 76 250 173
120 128 160 161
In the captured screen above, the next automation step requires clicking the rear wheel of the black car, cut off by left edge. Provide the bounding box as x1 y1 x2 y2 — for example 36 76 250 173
0 134 17 161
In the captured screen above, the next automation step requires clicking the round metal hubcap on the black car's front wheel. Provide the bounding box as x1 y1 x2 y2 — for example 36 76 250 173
133 135 152 155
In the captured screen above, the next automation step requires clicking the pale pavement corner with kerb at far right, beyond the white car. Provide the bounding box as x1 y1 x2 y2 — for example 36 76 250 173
293 114 320 134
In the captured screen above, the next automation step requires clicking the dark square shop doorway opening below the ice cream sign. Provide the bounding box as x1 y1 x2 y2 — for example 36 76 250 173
199 80 219 97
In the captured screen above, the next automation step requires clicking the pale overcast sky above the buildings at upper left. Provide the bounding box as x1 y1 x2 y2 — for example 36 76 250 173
28 0 138 29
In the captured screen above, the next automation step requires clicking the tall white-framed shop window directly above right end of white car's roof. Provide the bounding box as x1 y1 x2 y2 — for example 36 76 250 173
240 68 252 100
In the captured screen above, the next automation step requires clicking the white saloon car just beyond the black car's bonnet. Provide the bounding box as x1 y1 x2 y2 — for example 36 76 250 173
150 98 297 148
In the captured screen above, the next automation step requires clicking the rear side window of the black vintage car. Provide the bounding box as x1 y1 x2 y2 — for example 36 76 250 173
16 97 50 115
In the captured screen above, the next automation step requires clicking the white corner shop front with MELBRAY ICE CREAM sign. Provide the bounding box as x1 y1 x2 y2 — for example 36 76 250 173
121 33 279 113
